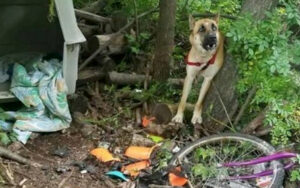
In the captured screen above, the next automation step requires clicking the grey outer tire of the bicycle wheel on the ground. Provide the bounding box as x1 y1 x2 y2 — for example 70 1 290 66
170 133 284 188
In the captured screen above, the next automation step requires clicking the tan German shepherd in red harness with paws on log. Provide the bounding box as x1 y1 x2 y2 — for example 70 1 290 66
172 15 224 124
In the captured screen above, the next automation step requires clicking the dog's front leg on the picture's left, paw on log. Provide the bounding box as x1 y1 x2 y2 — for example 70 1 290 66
172 67 197 123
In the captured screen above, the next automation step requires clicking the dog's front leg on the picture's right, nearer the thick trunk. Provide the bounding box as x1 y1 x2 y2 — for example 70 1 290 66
191 78 212 124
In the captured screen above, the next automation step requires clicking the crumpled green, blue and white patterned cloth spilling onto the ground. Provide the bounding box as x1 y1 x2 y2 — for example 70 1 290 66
0 56 71 143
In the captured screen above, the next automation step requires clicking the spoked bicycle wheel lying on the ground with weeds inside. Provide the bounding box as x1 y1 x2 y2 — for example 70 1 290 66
170 133 284 188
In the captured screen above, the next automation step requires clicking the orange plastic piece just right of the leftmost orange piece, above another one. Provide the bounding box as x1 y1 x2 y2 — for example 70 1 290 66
125 146 156 160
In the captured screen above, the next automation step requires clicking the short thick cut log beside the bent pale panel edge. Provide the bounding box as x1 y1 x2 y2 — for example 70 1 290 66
88 33 126 54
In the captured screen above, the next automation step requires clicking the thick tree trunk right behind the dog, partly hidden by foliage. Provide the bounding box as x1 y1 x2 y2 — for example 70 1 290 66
203 0 278 132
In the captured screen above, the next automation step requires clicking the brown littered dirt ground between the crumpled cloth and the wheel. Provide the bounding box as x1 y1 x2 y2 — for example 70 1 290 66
0 85 190 188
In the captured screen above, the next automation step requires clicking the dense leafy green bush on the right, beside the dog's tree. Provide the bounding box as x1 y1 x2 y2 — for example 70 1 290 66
226 2 300 145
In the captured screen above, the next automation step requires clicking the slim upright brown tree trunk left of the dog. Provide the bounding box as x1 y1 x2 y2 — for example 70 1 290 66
153 0 176 81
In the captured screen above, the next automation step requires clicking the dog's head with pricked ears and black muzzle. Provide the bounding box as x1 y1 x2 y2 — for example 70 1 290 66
189 16 219 51
